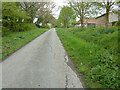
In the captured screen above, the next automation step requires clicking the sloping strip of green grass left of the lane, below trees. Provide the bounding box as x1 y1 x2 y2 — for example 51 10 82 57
0 28 48 58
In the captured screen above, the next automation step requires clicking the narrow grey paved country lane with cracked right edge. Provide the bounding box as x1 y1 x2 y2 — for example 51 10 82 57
0 28 83 88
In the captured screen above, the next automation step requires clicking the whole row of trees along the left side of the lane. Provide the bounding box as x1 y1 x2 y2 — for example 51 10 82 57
2 2 56 35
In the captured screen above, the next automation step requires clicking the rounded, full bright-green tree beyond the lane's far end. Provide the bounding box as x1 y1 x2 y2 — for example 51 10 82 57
58 6 76 28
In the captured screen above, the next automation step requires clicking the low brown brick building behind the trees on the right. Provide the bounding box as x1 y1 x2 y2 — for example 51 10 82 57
76 12 118 27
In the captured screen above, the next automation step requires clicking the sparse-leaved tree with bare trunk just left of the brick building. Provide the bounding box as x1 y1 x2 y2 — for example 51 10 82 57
69 0 92 27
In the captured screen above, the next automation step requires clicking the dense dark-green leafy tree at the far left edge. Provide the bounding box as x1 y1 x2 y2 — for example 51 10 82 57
2 2 29 32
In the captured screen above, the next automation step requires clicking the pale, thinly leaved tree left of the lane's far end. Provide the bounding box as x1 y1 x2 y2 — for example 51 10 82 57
36 2 55 27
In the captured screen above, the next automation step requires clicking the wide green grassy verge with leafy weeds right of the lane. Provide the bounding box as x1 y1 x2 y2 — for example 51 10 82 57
57 27 120 88
